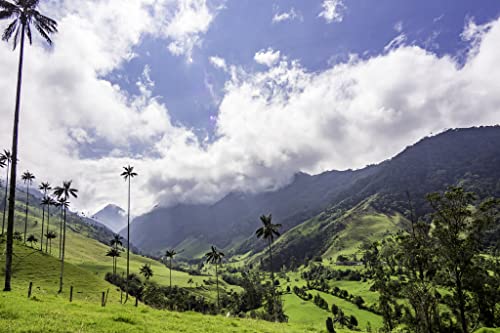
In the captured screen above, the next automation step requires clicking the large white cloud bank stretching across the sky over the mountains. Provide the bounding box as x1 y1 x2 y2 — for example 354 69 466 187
0 0 500 219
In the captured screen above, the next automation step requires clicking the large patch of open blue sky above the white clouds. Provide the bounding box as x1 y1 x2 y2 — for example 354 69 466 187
107 0 500 141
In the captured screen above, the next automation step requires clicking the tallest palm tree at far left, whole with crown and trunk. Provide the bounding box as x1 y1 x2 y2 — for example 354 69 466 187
0 0 57 291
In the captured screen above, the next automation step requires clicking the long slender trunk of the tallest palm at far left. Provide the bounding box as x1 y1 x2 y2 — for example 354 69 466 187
3 23 26 291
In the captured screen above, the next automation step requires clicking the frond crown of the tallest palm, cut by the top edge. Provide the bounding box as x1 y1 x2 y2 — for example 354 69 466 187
0 0 57 49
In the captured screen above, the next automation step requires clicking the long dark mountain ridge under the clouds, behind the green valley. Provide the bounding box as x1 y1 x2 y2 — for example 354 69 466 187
127 126 500 260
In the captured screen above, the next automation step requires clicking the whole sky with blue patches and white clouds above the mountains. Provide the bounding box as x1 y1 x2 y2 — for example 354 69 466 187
0 0 500 215
